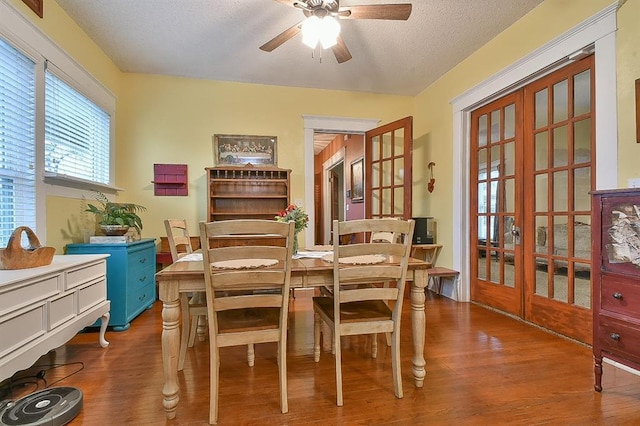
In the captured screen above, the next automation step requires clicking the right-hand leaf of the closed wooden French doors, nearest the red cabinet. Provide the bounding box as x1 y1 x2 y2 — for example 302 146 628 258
524 55 595 343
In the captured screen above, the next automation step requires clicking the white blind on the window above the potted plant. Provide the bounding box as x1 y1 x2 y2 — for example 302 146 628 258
45 67 111 184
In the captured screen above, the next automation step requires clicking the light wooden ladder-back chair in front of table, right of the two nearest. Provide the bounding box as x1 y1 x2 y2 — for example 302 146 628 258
313 219 414 406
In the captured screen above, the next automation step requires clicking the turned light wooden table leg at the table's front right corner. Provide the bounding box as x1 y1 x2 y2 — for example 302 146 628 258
411 269 427 388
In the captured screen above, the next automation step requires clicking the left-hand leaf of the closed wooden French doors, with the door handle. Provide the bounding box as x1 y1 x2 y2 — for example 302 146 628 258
470 91 523 316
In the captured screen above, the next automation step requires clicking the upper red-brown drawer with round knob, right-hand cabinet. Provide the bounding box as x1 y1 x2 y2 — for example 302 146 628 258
600 276 640 319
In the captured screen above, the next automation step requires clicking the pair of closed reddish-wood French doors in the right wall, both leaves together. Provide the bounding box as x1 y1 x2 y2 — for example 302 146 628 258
470 56 595 343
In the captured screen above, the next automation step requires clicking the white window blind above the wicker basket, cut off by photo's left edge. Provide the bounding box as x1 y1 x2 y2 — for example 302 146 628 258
0 39 36 247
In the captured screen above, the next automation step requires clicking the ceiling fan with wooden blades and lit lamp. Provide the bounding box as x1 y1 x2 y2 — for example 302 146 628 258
260 0 411 64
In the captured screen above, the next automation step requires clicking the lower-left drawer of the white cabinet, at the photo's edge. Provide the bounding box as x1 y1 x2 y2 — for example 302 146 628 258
0 303 45 363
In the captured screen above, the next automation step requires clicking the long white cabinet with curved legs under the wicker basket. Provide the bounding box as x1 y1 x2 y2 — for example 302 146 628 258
0 255 110 381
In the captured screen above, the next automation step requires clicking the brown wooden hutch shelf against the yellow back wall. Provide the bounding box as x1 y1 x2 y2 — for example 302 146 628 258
205 164 291 221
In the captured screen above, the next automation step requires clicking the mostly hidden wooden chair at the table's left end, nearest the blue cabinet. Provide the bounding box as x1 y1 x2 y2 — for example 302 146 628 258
164 219 207 371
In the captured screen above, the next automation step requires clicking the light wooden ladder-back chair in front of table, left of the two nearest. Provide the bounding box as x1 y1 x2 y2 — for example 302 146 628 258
200 219 295 424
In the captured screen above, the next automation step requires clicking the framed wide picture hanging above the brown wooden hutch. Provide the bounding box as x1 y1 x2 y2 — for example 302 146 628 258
213 135 278 166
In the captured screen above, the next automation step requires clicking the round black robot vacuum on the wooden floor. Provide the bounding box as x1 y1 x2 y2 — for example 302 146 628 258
0 387 82 426
